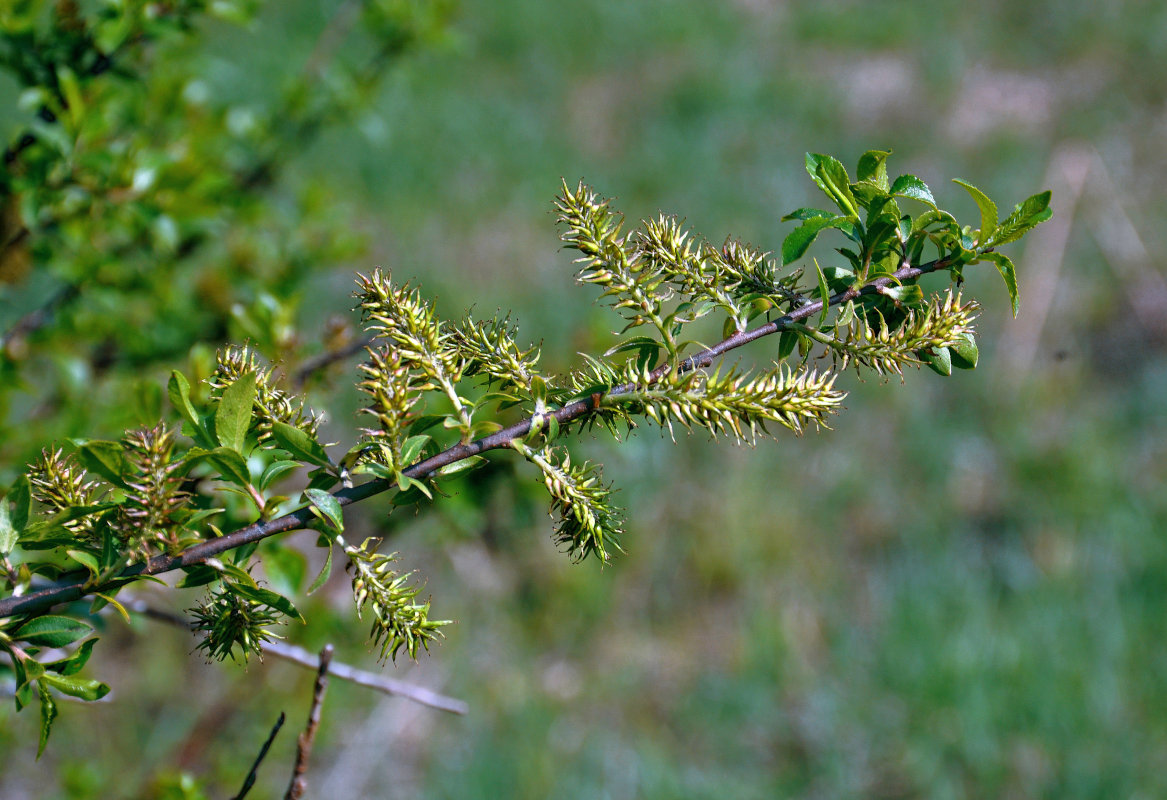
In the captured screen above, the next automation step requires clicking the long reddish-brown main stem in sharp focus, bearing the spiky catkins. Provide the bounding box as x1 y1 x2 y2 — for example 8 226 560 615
0 259 951 619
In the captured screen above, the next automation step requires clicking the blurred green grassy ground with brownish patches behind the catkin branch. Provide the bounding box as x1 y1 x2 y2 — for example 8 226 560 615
0 0 1167 800
